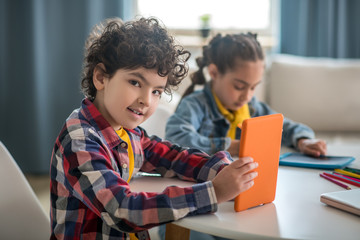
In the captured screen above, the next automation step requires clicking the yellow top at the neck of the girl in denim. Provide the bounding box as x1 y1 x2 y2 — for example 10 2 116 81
213 91 251 139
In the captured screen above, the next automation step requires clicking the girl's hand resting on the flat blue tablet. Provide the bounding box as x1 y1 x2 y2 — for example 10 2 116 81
298 138 327 157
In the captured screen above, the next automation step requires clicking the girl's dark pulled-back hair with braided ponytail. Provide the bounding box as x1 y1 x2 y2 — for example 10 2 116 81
182 33 264 98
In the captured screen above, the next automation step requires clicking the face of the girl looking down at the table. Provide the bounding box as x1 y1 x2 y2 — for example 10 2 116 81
208 60 264 111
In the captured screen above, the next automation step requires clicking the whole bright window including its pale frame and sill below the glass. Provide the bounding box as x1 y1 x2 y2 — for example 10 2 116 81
137 0 279 69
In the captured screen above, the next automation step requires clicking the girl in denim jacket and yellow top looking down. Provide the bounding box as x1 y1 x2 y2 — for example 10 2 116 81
166 33 326 156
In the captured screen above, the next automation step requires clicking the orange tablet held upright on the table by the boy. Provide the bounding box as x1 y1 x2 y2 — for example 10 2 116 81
234 113 284 212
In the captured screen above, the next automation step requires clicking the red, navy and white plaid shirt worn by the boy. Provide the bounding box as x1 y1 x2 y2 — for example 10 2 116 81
50 99 231 239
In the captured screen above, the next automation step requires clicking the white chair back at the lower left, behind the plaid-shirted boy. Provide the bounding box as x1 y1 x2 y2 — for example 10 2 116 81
0 141 50 240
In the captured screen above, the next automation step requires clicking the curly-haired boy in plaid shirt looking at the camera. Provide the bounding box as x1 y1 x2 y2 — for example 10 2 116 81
50 18 257 239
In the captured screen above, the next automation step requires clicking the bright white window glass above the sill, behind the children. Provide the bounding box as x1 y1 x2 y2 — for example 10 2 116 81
138 0 272 35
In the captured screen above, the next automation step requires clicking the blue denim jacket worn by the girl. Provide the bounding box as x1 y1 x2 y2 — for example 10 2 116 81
165 83 315 154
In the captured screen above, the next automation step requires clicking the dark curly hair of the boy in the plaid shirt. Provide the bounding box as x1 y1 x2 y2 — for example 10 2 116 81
81 18 190 101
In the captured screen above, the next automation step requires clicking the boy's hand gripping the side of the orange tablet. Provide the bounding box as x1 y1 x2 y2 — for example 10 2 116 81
212 157 258 203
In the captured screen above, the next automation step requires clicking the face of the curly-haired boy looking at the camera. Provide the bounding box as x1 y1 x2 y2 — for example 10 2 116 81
93 64 167 130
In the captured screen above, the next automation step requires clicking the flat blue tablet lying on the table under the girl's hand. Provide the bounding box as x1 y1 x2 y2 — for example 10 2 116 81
279 152 355 169
